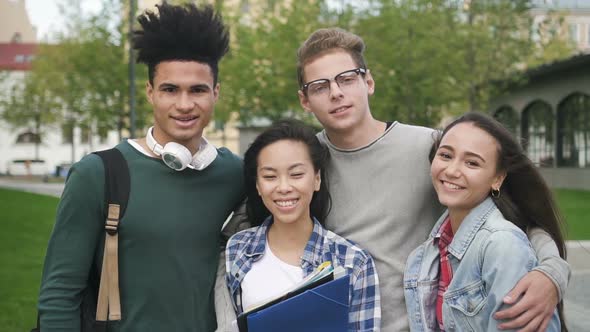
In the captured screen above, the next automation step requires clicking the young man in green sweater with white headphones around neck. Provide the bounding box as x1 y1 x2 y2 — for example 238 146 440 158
39 4 245 332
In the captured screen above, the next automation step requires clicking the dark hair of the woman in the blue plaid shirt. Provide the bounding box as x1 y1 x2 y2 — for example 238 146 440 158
244 120 331 226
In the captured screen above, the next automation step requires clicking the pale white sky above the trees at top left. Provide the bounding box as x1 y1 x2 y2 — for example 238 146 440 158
25 0 101 40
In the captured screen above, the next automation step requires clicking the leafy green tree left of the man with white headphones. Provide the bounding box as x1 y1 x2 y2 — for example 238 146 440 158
33 1 127 161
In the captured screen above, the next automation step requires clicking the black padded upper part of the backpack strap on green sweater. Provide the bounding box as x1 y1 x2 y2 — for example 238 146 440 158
93 148 131 219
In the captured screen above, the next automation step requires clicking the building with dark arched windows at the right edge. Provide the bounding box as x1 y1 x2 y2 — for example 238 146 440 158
490 54 590 190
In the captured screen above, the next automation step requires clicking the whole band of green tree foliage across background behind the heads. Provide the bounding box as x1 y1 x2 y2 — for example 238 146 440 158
3 0 572 134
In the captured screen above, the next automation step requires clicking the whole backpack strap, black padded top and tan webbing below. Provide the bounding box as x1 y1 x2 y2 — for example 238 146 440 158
93 148 130 322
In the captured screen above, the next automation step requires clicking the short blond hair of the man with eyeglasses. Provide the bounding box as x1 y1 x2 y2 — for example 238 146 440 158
297 28 367 87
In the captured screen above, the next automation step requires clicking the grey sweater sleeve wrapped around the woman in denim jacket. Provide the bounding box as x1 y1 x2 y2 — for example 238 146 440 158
527 227 571 301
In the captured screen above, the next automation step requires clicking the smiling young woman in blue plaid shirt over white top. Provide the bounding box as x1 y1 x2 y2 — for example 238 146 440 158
225 120 381 332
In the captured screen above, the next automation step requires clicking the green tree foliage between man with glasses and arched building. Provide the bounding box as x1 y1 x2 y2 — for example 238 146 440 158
351 0 568 126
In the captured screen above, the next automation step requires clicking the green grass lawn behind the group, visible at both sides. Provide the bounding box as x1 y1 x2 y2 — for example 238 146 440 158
0 188 590 332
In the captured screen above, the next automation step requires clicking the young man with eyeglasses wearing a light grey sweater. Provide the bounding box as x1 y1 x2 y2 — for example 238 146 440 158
297 28 570 331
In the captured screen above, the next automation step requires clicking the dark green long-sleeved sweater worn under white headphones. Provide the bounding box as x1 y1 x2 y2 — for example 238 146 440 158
39 142 244 332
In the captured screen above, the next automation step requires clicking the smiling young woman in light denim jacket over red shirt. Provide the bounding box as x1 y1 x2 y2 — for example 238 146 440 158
404 113 566 331
